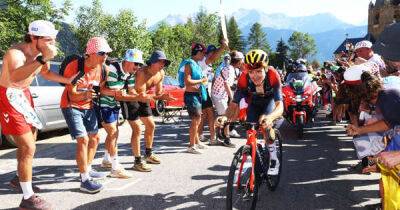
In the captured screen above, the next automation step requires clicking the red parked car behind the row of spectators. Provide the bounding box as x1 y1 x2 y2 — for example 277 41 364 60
149 76 185 116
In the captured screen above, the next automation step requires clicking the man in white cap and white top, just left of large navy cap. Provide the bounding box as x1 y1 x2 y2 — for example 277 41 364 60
354 40 385 76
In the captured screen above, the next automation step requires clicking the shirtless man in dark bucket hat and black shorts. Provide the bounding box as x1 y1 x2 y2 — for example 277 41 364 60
128 50 175 172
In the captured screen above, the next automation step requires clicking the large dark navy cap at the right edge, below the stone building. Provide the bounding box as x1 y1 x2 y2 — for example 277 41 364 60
372 23 400 62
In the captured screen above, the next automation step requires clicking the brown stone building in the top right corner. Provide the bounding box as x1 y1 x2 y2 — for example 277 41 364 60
368 0 400 39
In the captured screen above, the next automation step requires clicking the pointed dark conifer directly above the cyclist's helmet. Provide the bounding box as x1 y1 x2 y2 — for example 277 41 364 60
247 23 271 53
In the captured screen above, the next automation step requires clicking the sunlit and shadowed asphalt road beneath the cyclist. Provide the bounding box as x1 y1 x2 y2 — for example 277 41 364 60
0 110 379 210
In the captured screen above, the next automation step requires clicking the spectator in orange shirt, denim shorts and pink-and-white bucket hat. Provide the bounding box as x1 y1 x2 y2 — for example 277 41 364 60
60 37 112 193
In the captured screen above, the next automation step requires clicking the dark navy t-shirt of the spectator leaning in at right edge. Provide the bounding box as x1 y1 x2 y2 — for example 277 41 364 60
376 89 400 128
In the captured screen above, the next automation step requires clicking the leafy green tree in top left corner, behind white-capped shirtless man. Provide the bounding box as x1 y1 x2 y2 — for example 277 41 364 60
0 0 71 57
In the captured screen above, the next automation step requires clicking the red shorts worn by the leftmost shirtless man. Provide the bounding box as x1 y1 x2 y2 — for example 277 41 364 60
0 86 33 136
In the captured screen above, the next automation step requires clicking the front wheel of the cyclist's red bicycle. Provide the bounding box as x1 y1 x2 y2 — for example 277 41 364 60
226 145 257 210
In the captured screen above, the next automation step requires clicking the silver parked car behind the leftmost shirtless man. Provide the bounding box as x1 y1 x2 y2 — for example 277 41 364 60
0 61 67 146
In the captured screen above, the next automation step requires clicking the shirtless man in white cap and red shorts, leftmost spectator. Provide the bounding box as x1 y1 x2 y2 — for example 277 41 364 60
0 20 73 209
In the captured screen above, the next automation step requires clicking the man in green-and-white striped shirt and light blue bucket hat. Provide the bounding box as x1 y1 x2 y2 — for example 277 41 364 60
100 49 150 178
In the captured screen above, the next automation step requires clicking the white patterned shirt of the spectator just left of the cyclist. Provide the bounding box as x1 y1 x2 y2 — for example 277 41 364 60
211 65 235 99
